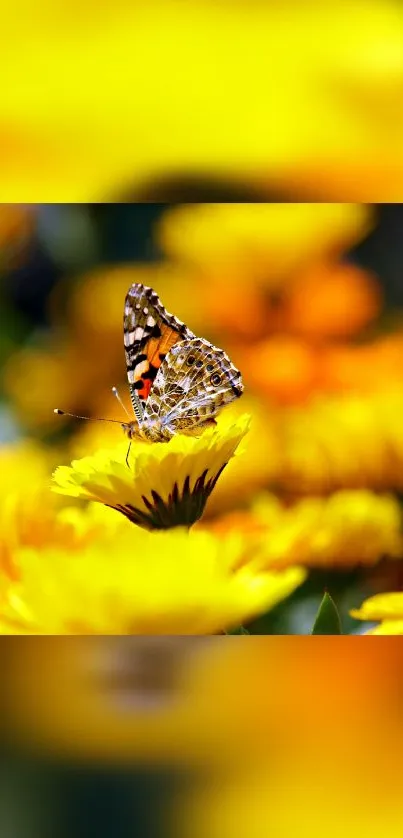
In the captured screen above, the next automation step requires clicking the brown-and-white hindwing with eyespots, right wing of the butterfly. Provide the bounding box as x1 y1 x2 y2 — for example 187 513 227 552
145 338 243 435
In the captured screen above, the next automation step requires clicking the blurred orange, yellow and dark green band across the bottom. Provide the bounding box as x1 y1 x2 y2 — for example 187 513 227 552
0 636 403 838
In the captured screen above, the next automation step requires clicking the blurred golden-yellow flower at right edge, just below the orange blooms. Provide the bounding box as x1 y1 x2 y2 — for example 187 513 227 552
277 387 403 495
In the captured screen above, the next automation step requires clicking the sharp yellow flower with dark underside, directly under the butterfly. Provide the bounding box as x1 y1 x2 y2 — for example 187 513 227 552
54 415 249 529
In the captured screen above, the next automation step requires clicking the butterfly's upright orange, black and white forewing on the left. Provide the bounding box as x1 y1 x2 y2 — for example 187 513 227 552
124 283 194 407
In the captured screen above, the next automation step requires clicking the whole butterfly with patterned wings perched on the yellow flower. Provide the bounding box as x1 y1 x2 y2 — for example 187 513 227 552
122 283 243 442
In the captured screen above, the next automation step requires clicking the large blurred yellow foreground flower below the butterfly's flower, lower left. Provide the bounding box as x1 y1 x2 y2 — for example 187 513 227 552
0 524 305 634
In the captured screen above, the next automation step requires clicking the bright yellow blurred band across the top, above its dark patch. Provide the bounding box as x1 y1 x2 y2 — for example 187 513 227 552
0 0 403 201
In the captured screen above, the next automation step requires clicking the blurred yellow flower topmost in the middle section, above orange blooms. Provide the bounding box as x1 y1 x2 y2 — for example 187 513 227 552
159 203 371 286
